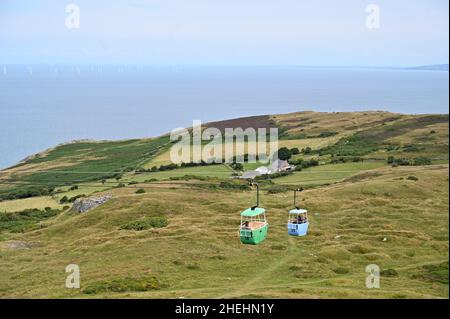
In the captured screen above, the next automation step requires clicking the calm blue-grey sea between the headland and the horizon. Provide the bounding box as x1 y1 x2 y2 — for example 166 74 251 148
0 65 449 169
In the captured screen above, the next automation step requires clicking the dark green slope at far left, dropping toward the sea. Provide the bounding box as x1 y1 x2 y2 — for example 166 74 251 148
0 136 170 197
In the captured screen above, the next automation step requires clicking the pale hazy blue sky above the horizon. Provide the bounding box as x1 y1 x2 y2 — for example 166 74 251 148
0 0 449 67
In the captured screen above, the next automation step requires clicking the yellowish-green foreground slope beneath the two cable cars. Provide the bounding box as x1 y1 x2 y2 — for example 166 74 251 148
0 166 448 298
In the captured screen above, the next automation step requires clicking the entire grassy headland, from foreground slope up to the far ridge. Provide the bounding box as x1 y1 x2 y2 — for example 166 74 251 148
0 112 449 298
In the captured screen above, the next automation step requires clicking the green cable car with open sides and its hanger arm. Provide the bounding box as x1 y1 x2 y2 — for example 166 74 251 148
239 183 269 245
